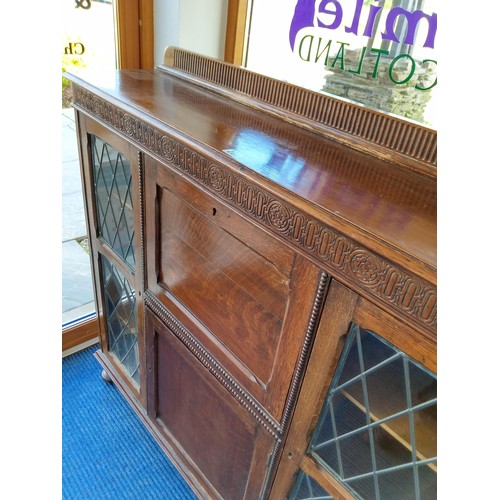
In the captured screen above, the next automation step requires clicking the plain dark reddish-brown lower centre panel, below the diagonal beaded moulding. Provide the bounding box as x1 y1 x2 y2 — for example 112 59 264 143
148 316 274 499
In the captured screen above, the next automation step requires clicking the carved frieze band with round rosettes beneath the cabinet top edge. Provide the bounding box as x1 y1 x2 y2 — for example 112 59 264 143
74 85 437 336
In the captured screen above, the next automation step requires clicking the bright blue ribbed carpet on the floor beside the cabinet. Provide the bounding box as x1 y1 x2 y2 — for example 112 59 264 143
62 346 196 500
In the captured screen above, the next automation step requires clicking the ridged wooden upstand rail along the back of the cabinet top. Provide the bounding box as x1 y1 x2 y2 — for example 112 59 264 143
159 47 437 177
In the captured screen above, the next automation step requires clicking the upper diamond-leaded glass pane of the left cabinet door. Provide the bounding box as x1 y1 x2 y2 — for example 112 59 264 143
91 135 135 270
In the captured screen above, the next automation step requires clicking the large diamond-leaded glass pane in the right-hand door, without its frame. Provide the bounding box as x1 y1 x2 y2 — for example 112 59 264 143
308 325 437 500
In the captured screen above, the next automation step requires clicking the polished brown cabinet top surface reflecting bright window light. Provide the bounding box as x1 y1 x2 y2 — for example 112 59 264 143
67 68 437 284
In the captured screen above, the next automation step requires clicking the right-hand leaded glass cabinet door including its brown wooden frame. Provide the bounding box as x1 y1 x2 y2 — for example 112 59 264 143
272 282 437 500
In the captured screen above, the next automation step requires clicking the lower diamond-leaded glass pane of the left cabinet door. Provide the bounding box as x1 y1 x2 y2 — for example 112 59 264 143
101 256 140 386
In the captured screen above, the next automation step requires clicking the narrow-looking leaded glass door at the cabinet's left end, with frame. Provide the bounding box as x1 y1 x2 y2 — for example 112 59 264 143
80 117 145 403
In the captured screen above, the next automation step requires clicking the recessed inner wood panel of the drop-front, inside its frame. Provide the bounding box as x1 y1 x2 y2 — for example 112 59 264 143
159 190 289 383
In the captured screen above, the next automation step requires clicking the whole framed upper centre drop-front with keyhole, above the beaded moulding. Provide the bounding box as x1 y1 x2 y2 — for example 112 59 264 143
145 157 321 420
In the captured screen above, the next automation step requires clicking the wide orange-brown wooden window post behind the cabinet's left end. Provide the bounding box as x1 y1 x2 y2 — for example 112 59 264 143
115 0 154 69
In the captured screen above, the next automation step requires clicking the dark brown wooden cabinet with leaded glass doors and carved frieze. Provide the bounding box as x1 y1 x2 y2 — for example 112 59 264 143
69 49 437 500
